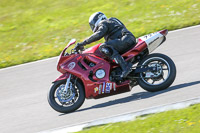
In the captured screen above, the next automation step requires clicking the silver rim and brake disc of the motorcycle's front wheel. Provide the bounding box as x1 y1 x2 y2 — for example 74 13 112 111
54 82 79 107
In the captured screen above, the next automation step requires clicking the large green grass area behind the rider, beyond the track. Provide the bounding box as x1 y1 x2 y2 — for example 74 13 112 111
0 0 200 68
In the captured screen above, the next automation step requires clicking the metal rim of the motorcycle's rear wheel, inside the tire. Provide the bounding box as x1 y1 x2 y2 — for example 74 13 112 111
140 57 171 85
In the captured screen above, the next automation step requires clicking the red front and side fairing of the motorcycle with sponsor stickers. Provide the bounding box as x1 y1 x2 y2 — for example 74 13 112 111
55 41 130 98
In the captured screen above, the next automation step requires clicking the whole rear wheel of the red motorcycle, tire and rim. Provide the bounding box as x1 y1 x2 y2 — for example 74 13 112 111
137 53 176 92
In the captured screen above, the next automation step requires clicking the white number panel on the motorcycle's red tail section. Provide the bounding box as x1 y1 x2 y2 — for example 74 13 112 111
139 32 164 53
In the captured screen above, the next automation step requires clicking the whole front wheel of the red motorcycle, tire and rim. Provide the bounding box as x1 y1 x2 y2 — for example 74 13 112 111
47 80 85 113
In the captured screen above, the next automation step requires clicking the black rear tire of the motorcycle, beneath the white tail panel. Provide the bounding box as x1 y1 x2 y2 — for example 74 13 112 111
137 53 176 92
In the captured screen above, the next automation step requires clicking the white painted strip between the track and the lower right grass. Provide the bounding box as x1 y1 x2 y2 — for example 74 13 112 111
39 97 200 133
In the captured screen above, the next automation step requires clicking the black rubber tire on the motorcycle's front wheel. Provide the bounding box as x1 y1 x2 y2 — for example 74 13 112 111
47 80 85 113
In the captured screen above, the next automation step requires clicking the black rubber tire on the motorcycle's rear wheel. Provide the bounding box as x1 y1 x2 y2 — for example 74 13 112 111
137 53 176 92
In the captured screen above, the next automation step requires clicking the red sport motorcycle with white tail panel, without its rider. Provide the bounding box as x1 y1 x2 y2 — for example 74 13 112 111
48 30 176 113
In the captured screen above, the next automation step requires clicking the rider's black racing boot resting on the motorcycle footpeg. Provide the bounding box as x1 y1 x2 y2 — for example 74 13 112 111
113 54 132 78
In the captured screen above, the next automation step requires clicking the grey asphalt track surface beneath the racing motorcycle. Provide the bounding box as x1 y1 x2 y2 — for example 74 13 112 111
0 26 200 133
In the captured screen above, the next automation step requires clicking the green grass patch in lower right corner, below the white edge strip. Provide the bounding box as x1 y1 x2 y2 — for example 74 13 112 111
79 104 200 133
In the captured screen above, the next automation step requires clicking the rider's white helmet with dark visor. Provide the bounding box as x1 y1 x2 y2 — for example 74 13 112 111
89 12 107 32
